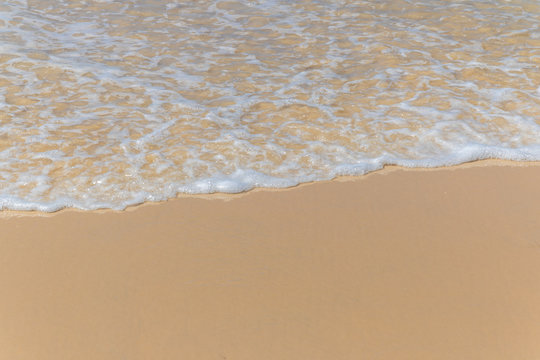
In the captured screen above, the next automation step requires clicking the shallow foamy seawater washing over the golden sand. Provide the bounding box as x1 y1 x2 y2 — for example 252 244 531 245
0 0 540 211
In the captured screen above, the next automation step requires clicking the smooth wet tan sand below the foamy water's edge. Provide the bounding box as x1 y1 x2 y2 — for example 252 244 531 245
0 162 540 360
